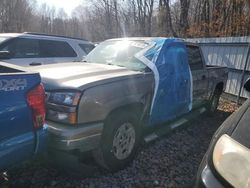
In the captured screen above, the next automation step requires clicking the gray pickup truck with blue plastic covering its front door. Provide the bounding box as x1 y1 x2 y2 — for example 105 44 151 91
28 38 228 170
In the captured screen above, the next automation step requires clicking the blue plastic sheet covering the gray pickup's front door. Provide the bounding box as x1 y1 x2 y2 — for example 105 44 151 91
150 42 192 124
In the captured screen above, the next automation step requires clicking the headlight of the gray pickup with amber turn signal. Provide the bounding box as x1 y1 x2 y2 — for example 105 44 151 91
46 92 81 124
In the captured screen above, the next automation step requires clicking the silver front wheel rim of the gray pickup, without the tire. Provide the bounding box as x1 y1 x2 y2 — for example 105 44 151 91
112 123 135 160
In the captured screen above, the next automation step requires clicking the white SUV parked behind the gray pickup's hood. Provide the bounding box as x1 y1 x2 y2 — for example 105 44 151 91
0 32 95 66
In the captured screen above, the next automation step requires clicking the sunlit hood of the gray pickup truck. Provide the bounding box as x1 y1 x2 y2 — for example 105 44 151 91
28 62 142 91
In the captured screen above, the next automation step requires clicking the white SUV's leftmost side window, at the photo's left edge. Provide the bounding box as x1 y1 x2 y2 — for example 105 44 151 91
1 38 40 58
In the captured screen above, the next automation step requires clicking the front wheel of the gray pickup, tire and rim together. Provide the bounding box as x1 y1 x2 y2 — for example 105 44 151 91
93 111 141 172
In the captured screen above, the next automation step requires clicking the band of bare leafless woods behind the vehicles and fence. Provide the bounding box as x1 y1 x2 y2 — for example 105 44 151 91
0 0 250 41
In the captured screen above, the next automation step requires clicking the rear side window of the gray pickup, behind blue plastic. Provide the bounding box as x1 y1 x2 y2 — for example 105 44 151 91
187 46 203 70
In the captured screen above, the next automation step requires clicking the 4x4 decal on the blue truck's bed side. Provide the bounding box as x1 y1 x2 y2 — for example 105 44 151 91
0 79 27 91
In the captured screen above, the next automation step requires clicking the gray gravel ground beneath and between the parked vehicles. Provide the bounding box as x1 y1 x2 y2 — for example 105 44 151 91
0 100 237 188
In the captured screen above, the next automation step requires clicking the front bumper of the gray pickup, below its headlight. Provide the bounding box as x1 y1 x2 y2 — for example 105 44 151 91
47 122 103 152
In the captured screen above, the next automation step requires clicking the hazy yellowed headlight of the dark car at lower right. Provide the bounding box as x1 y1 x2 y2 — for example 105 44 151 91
213 134 250 188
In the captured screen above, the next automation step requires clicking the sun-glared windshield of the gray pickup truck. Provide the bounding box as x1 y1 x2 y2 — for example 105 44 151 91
85 40 148 71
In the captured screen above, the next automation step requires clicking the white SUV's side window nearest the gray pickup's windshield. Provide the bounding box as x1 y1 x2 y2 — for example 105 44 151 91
39 40 77 57
